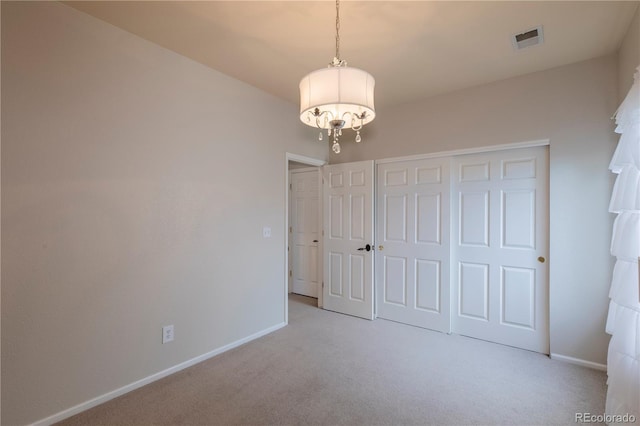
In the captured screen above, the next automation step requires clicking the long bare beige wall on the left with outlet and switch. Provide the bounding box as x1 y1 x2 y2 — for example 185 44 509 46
2 2 328 424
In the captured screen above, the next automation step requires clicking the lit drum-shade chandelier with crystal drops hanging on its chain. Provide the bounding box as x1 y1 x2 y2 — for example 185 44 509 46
300 0 376 154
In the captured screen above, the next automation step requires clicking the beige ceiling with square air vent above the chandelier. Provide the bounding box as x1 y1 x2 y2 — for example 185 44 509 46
66 0 640 108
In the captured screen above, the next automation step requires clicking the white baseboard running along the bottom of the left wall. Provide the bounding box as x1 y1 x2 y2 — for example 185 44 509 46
32 322 287 426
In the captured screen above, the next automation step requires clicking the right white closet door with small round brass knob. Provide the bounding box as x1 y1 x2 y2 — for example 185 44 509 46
452 147 549 353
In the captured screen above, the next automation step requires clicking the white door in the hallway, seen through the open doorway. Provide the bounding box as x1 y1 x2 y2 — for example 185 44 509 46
290 169 321 298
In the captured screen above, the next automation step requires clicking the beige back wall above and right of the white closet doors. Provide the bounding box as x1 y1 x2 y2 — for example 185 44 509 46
331 55 617 364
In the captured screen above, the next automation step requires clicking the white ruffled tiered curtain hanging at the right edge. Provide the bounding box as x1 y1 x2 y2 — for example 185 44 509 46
605 66 640 424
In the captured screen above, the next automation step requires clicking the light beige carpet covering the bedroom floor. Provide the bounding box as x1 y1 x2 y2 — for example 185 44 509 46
62 296 606 425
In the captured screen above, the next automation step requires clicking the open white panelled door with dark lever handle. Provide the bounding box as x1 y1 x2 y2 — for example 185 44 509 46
323 161 374 319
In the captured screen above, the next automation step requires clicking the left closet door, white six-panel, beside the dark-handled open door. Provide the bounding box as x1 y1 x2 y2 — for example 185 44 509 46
376 157 451 333
